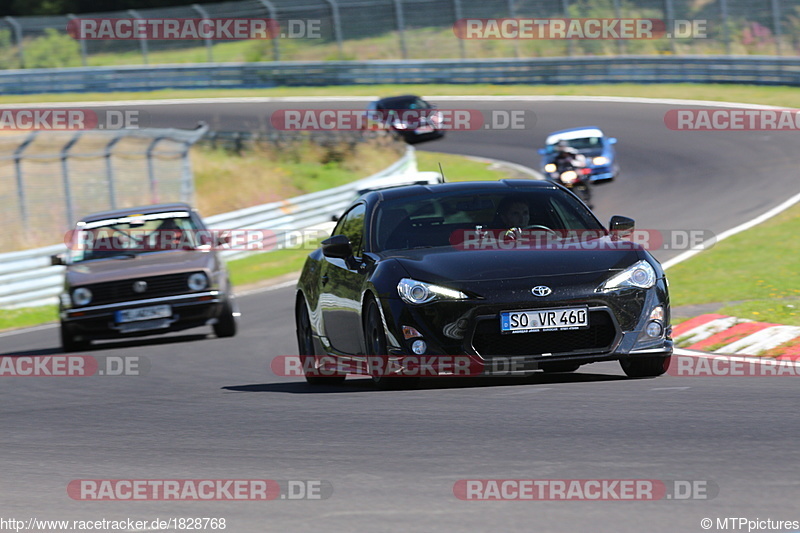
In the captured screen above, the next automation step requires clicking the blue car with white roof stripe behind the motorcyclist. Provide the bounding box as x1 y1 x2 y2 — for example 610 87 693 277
539 126 619 183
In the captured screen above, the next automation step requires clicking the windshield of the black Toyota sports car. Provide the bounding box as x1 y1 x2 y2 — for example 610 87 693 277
372 189 605 252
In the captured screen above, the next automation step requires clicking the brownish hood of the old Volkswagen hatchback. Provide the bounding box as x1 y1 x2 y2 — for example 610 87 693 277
66 250 215 287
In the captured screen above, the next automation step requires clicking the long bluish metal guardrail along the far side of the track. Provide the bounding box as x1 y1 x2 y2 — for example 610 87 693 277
0 56 800 94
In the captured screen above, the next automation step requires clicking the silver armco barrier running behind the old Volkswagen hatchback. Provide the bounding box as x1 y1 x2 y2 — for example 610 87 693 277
0 146 417 309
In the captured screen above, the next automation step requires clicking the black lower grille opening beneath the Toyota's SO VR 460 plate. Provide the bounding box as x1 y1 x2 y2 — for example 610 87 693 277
472 310 617 358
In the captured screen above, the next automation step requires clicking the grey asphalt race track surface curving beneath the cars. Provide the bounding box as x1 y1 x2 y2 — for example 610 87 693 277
0 98 800 533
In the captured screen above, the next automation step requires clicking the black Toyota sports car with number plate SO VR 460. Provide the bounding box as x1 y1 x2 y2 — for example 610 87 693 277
295 180 672 387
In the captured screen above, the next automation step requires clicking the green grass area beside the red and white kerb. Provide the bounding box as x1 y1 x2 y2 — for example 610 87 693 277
667 200 800 326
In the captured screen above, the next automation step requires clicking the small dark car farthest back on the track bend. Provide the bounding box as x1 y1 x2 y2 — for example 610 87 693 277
367 94 444 144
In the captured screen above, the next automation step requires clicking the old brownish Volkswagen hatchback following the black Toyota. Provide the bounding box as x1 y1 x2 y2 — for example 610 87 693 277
52 203 239 352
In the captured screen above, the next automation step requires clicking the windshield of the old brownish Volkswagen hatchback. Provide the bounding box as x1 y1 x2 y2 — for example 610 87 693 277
69 211 202 263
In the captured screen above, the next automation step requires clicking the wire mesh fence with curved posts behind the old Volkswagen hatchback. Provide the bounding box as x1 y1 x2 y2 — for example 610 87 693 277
0 127 207 255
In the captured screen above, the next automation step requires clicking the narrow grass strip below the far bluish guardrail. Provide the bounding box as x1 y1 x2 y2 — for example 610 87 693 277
0 83 798 107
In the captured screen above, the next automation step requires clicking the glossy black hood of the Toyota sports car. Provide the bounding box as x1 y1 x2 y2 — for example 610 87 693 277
390 238 642 287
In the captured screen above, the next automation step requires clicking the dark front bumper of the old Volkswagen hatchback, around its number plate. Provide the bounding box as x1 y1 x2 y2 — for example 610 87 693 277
60 290 225 340
